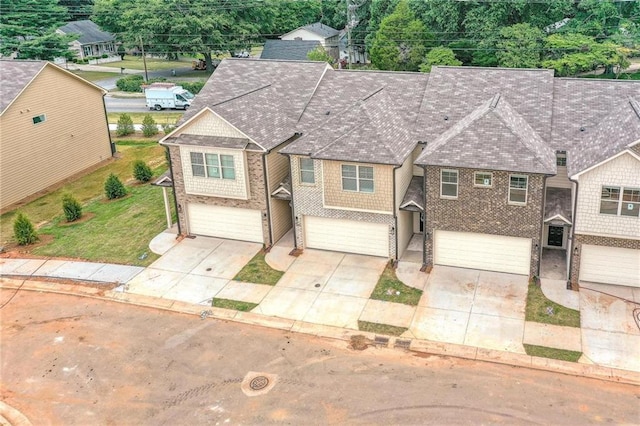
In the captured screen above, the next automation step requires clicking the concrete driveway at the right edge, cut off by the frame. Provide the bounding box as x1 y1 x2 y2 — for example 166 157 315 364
580 283 640 371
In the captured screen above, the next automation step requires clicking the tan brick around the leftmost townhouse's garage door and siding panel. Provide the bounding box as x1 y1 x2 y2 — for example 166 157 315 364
169 146 269 245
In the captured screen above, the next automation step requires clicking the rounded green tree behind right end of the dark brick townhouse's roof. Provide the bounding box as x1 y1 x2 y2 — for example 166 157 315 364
496 24 544 68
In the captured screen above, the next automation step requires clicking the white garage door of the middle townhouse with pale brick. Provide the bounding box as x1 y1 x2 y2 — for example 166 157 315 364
304 216 389 257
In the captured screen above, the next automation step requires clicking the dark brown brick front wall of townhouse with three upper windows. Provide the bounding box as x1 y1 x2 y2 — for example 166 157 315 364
425 166 544 275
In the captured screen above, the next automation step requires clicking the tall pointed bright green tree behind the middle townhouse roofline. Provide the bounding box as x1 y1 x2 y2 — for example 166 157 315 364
371 0 431 71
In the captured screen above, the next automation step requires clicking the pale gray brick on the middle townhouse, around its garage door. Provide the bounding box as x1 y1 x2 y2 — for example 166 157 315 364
291 155 396 258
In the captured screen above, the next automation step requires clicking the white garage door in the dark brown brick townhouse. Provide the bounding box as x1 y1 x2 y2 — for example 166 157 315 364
434 231 531 275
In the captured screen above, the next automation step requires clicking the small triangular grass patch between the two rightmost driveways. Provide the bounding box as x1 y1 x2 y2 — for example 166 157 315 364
525 280 580 327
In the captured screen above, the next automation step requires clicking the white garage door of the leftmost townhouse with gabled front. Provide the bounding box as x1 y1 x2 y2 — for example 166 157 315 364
187 204 264 243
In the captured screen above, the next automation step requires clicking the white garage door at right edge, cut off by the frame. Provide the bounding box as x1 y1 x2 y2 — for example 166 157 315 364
579 244 640 287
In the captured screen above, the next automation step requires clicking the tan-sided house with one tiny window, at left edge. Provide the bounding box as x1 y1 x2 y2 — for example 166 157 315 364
0 60 114 210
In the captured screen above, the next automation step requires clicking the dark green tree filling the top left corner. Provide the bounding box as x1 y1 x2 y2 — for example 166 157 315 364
0 0 73 60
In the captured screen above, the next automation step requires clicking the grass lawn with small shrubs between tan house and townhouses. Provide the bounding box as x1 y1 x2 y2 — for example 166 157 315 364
0 140 167 265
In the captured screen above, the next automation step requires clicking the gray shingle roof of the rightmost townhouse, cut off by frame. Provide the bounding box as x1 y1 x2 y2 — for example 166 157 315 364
551 79 640 176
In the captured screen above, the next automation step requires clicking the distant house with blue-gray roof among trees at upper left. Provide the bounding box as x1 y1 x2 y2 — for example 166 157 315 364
56 20 117 59
